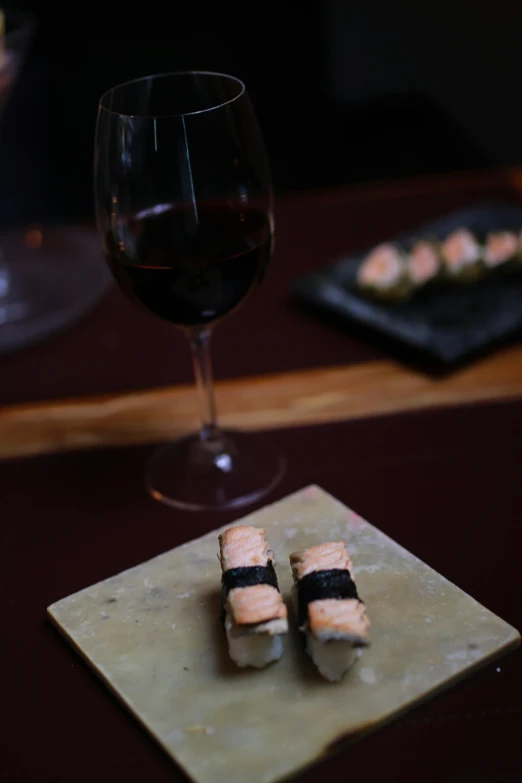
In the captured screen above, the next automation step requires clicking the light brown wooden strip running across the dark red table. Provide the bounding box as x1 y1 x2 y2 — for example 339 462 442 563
0 346 522 459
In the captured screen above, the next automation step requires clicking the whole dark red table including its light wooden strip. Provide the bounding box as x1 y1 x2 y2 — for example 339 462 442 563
0 171 522 783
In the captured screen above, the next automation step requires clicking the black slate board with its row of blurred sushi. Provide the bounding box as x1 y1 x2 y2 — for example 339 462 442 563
292 201 522 366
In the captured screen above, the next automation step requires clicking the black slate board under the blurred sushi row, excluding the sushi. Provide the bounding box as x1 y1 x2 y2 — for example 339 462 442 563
292 202 522 364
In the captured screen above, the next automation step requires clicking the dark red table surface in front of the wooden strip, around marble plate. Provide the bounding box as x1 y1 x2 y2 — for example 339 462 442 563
0 401 522 783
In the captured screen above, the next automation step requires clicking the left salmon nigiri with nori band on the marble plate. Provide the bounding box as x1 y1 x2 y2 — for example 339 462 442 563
219 525 288 668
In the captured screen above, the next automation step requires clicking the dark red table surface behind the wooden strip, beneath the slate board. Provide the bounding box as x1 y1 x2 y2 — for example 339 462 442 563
0 172 520 403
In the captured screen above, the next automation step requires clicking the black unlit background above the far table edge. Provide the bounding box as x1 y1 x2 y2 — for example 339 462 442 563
0 0 522 223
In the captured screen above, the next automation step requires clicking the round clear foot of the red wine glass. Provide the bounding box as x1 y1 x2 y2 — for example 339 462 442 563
147 431 286 511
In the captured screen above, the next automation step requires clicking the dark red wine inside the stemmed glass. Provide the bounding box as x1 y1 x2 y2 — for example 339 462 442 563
105 204 272 326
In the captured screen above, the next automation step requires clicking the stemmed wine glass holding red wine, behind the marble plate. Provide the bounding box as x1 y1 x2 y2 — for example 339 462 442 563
94 71 284 510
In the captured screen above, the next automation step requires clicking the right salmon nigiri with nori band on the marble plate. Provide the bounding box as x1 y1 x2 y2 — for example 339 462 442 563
290 541 370 681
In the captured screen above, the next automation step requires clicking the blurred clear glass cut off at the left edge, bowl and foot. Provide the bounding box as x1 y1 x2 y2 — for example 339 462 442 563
0 9 110 354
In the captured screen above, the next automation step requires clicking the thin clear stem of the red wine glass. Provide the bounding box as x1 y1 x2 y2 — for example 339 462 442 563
189 327 221 446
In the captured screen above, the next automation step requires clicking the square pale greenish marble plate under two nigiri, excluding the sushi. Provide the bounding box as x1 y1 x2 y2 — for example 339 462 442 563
48 486 520 783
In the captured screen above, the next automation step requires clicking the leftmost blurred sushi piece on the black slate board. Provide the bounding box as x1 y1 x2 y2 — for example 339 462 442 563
357 243 411 301
